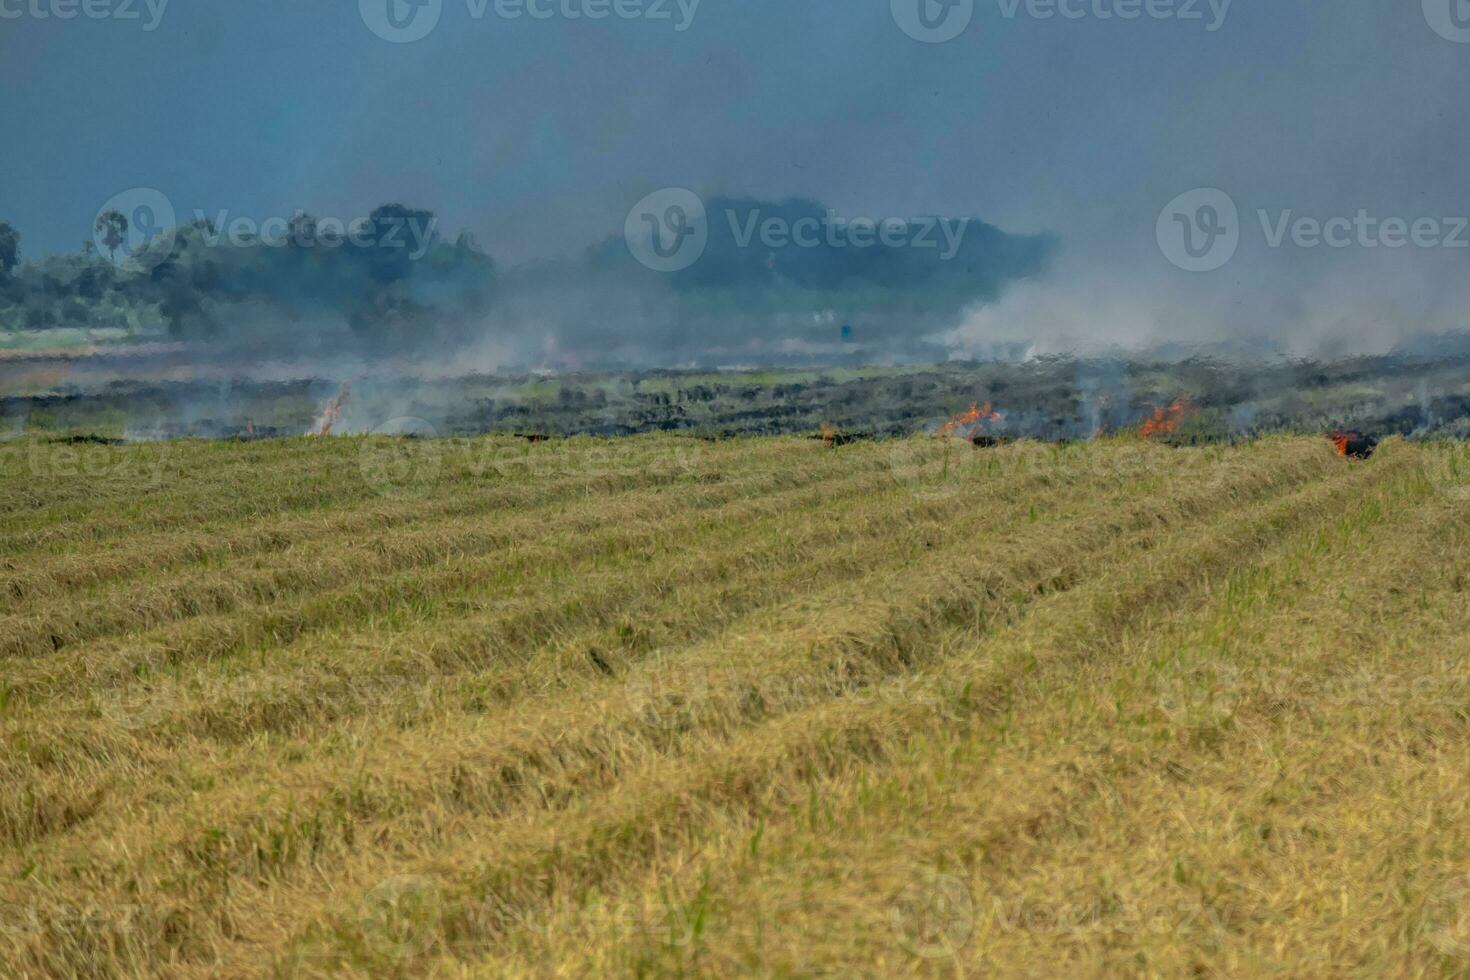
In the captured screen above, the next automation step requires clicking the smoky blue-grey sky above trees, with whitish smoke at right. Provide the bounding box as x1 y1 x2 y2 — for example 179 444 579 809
0 0 1470 353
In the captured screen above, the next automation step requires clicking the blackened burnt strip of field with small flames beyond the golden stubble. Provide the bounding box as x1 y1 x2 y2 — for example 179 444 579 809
0 351 1470 441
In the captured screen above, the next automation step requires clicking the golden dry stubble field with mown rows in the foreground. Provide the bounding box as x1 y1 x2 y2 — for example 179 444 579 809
0 436 1470 977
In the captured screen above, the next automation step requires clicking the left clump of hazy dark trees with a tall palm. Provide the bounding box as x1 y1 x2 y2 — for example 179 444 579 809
0 204 495 342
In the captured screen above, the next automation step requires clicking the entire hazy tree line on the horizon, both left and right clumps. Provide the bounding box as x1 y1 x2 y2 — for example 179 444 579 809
0 197 1057 366
